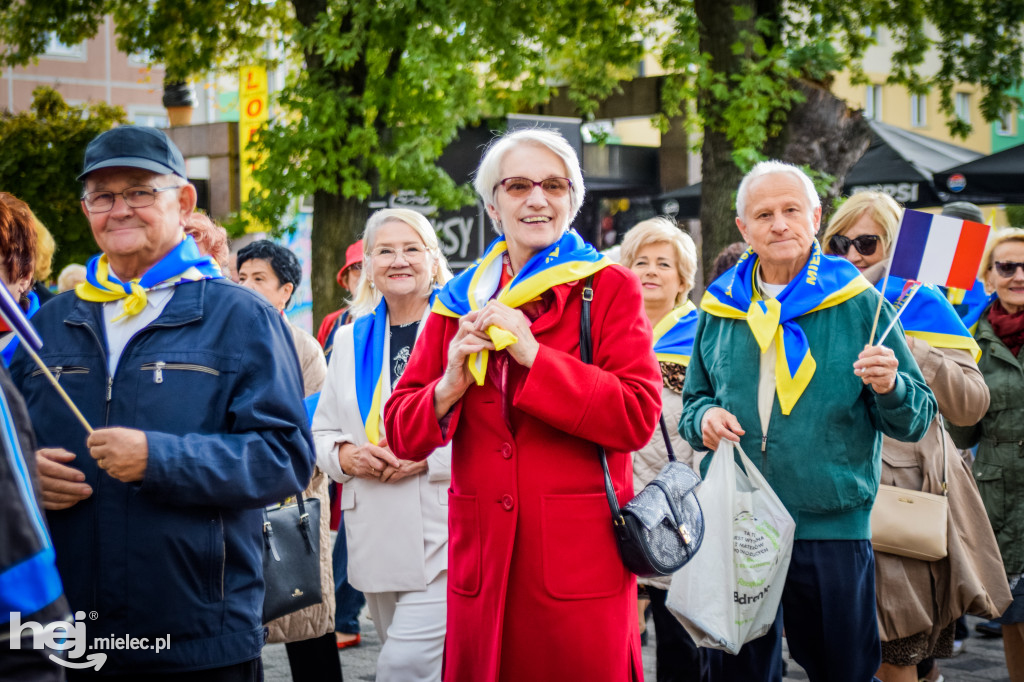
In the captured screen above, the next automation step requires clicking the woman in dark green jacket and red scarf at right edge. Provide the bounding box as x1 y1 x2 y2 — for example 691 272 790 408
950 229 1024 682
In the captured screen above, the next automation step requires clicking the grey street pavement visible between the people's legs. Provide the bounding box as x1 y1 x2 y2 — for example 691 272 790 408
263 609 1010 682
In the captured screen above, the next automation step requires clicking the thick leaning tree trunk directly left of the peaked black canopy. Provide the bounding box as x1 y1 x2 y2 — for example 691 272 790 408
768 81 871 219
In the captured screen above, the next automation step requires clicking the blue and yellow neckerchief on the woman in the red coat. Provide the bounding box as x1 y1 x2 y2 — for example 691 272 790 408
433 229 612 386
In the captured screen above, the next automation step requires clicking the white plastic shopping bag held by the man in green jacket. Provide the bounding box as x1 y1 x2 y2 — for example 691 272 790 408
666 438 797 653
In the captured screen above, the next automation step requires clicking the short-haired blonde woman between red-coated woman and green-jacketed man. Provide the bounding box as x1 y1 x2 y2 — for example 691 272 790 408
620 218 701 682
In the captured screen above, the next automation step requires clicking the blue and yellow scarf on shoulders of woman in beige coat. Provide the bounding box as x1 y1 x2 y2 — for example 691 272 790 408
876 276 981 363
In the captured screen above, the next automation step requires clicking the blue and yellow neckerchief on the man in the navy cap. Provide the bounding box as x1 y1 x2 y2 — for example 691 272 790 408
75 233 224 322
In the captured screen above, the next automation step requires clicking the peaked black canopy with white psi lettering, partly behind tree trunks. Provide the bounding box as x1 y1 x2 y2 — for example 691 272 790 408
658 121 982 218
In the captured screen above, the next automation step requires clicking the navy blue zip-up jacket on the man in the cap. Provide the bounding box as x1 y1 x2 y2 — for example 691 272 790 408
11 280 314 674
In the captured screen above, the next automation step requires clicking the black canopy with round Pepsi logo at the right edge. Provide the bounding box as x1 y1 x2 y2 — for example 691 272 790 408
935 144 1024 204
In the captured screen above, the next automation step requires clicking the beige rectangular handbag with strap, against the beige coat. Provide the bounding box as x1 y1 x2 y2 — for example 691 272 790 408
871 417 949 561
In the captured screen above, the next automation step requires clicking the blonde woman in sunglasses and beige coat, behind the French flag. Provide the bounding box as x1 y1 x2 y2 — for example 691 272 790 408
823 191 1009 682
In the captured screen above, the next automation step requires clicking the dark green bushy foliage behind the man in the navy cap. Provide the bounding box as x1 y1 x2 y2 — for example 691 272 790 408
0 86 126 271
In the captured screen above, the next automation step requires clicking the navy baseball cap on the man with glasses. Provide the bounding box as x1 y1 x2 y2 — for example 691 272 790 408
78 126 188 180
